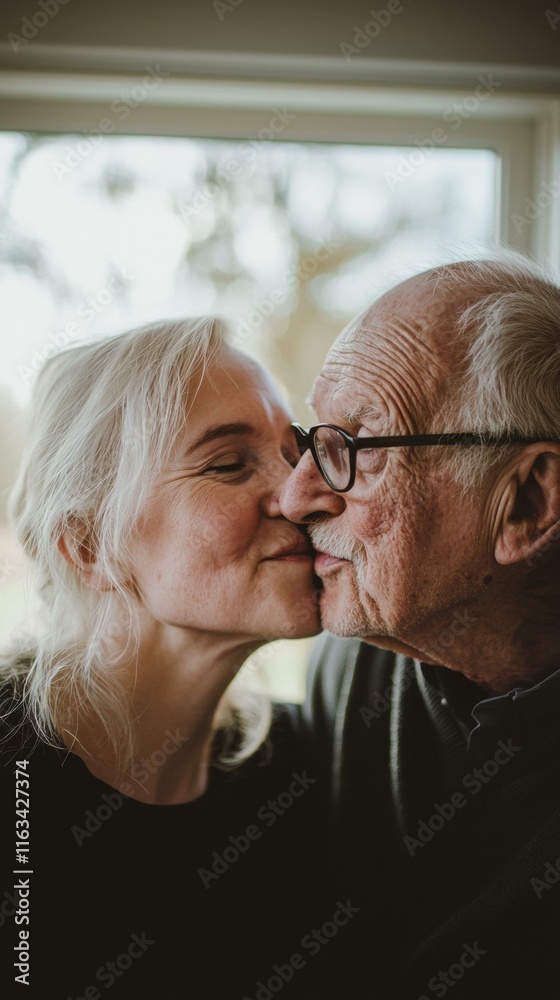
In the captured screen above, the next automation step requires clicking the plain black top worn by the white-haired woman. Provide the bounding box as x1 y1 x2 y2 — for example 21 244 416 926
0 706 336 1000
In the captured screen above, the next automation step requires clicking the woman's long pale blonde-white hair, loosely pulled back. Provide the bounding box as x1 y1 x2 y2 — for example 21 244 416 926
0 317 271 767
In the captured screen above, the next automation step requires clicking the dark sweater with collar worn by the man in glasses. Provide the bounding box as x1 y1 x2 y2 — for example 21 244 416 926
307 638 560 1000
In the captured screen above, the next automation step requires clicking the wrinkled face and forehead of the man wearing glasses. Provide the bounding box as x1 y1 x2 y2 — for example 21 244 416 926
281 278 492 662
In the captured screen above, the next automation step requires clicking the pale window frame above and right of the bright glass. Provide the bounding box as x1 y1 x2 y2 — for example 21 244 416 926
0 72 560 269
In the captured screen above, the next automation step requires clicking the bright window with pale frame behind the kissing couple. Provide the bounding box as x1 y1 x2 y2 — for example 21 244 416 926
0 74 560 696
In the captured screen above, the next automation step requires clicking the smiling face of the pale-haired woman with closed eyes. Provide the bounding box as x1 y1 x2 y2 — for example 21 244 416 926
126 348 319 639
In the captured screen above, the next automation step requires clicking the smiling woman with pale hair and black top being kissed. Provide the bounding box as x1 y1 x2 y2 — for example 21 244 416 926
0 318 328 1000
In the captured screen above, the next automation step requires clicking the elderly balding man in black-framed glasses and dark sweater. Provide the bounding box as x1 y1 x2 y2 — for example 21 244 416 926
281 254 560 1000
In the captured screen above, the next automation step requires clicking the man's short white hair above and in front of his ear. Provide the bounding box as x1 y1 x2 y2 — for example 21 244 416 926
431 250 560 489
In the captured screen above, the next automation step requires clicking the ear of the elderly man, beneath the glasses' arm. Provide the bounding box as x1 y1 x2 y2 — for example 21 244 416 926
494 444 560 566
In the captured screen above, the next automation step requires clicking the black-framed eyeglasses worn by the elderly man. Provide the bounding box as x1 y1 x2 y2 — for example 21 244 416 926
292 424 541 493
